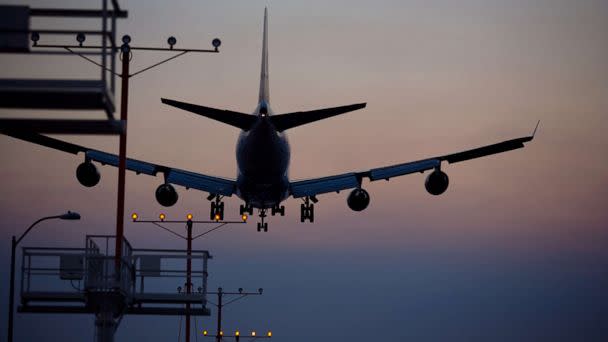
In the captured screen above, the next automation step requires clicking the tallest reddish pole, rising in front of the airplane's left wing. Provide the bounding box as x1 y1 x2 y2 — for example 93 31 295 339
115 43 131 270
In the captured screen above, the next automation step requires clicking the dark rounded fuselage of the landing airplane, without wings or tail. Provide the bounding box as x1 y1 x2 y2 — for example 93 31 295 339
236 103 290 209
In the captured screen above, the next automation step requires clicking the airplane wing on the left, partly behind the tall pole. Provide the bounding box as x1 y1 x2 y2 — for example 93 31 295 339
0 131 236 196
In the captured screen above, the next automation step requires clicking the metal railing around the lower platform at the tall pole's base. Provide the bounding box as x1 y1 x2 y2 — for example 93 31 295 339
21 235 211 308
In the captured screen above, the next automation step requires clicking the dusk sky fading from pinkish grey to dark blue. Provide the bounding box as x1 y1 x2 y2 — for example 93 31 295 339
0 0 608 342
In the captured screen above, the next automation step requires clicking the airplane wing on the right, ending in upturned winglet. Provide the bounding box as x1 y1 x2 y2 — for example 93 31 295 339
290 121 540 198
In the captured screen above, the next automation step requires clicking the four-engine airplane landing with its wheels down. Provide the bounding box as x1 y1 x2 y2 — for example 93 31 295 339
0 9 540 231
